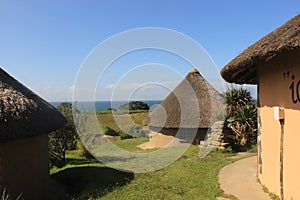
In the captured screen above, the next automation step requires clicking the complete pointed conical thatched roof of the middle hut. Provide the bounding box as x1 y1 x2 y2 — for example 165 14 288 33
144 69 224 128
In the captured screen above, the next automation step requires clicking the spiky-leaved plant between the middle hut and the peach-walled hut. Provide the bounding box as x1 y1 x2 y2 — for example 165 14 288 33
225 87 257 151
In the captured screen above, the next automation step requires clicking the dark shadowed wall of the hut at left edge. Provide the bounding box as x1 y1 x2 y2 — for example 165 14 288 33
0 134 49 199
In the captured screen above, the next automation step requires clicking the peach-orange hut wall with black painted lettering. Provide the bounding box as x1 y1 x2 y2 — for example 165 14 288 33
257 50 300 199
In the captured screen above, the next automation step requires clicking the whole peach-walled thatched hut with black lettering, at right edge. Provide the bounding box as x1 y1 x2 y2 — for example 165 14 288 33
221 15 300 199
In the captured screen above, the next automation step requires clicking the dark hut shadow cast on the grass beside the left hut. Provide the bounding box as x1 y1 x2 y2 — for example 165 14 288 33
52 167 134 199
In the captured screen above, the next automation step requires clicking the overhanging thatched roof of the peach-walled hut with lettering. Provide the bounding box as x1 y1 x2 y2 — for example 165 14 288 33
221 15 300 84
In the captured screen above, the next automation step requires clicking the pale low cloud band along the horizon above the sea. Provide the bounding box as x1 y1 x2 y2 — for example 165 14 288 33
30 80 248 102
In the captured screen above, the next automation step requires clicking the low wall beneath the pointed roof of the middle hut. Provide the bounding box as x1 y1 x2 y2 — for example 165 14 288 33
150 126 208 144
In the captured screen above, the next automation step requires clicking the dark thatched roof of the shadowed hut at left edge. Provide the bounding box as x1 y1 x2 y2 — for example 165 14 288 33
0 68 67 141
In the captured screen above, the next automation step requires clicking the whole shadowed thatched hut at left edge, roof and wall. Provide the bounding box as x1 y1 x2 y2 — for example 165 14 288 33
0 68 66 199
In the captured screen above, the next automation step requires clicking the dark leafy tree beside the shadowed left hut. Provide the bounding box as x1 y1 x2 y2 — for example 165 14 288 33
49 102 78 167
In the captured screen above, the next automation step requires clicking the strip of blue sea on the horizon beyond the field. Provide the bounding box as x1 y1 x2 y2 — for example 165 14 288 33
50 100 162 112
